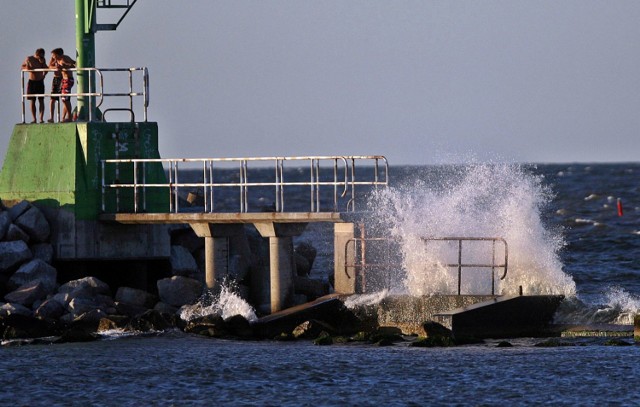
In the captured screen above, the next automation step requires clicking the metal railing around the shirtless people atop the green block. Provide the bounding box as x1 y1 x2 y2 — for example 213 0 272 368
20 68 149 123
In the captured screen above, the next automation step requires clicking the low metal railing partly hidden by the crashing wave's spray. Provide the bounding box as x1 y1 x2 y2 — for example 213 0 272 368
344 237 509 295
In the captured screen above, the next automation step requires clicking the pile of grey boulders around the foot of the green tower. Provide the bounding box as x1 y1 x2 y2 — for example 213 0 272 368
0 201 336 342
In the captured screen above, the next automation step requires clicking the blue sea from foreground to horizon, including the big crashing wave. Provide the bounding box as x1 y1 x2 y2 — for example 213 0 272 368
0 163 640 406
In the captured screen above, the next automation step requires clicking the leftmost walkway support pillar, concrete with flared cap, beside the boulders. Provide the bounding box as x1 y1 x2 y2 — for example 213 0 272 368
190 223 244 290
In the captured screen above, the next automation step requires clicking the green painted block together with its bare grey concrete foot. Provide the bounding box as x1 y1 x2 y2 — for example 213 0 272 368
0 122 170 261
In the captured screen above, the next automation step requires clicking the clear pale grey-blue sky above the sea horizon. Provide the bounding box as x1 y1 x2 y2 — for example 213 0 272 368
0 0 640 165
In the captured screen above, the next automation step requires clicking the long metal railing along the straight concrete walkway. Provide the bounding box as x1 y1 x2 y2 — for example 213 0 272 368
101 155 389 213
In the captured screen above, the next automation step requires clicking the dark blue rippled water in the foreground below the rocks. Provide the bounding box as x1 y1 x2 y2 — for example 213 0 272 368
0 335 640 406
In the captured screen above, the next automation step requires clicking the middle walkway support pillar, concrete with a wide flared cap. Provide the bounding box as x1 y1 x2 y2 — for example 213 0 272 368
255 222 307 313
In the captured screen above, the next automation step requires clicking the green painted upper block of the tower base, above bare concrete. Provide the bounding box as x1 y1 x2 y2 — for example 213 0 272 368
0 122 169 220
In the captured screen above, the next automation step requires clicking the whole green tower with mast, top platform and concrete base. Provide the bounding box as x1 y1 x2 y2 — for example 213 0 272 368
0 0 170 262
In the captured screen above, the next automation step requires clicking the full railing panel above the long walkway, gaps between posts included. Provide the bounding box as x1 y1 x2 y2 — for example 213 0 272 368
102 155 389 213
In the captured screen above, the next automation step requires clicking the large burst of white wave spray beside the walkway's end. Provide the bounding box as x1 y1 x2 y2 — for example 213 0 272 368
362 164 576 296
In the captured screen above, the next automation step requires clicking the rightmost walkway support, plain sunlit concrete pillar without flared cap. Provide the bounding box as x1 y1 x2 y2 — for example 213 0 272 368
333 223 356 294
